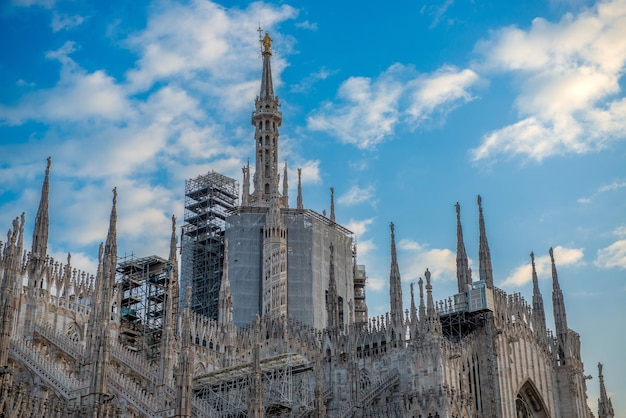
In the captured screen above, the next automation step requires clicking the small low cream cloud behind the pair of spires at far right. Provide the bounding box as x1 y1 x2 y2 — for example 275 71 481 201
501 246 584 287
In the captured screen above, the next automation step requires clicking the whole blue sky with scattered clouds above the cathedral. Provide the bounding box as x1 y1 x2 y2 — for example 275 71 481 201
0 0 626 412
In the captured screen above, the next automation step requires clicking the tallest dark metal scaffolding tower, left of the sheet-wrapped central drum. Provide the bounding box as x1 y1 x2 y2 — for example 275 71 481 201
180 171 239 320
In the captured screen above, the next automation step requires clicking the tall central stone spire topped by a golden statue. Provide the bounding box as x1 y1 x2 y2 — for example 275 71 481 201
250 32 283 207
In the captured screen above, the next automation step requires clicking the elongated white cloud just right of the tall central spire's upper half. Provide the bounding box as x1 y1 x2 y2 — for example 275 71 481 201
307 64 478 149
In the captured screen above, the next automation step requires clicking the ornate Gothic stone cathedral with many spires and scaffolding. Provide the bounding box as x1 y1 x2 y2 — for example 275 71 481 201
0 33 614 418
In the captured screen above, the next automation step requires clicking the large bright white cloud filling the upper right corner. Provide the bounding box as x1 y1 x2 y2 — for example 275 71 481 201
472 0 626 161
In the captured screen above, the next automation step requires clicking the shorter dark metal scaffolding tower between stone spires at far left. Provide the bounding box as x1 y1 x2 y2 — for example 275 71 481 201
117 255 170 360
